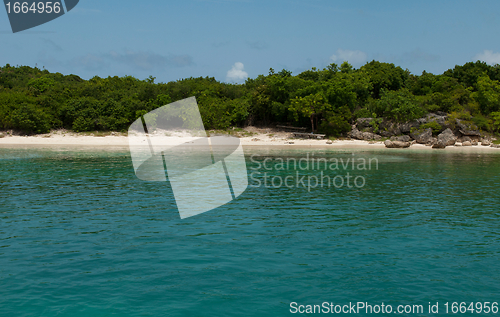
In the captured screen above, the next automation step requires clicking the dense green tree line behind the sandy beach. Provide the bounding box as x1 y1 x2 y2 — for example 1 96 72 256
0 61 500 135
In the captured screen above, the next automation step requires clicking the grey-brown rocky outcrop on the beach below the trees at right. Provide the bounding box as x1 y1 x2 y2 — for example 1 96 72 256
348 112 495 149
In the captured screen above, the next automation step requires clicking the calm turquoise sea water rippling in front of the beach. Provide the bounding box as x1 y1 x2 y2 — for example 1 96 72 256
0 149 500 316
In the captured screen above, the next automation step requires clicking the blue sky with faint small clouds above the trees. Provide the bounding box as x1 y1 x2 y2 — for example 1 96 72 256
0 0 500 82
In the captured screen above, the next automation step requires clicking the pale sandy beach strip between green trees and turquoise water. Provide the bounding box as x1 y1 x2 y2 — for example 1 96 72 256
0 131 500 154
